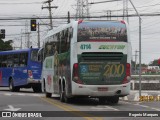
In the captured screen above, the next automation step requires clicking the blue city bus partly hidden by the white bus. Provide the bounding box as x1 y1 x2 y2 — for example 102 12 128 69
0 48 42 92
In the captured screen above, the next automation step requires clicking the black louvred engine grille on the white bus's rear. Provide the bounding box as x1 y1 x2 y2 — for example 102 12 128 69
80 52 123 62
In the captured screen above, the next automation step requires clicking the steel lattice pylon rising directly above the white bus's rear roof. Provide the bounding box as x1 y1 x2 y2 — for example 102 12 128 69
76 0 90 19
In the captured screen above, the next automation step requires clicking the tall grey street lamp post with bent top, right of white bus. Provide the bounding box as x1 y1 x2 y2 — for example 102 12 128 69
129 0 142 96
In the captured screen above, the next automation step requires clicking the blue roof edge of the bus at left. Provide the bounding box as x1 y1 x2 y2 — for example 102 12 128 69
0 48 39 55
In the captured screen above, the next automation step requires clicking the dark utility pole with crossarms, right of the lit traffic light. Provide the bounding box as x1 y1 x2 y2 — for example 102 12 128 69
42 0 58 29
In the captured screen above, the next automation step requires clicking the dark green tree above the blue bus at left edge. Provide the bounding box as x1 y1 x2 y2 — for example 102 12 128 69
0 39 13 51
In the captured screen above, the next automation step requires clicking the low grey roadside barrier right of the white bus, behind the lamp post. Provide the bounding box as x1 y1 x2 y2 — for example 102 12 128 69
131 75 160 90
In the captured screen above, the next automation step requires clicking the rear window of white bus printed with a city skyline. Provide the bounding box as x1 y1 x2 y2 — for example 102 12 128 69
77 21 127 42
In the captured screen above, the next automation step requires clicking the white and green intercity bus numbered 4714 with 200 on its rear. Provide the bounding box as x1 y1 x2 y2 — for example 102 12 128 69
41 20 132 103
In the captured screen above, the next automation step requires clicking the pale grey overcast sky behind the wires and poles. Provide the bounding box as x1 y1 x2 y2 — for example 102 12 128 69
0 0 160 64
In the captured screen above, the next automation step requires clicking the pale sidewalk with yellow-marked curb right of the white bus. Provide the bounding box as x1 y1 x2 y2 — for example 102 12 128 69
120 90 160 101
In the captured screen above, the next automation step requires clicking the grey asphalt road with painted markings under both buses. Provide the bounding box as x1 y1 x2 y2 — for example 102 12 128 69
0 88 160 120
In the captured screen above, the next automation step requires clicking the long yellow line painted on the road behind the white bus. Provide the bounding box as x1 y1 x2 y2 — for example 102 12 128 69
40 97 103 120
